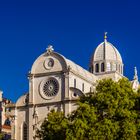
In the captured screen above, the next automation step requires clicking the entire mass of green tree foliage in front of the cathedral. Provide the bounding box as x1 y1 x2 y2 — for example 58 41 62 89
37 79 140 140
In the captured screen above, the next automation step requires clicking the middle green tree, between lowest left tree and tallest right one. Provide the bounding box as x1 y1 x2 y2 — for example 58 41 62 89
66 102 97 140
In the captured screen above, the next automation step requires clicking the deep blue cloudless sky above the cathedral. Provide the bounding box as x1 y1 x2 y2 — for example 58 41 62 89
0 0 140 101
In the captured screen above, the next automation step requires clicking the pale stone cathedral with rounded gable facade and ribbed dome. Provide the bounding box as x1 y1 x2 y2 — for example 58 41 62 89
8 34 139 140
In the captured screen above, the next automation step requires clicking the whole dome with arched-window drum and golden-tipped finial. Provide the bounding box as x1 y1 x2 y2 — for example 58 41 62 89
89 33 123 75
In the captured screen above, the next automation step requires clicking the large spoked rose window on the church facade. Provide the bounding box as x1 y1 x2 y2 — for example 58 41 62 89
40 78 59 99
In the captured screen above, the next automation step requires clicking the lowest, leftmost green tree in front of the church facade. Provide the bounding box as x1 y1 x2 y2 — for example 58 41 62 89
37 110 68 140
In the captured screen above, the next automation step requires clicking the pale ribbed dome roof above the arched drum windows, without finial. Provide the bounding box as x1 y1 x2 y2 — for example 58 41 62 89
92 41 122 63
